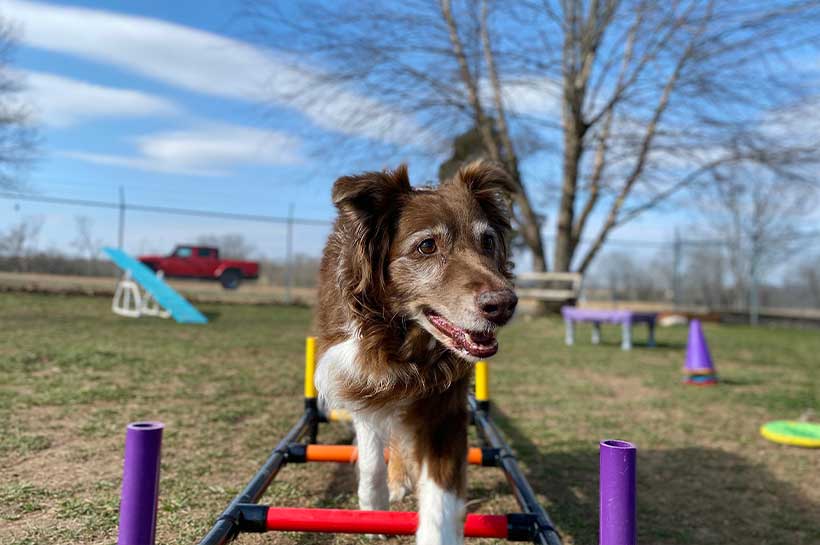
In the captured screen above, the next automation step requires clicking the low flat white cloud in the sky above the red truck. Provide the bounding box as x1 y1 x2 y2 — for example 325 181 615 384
61 124 303 176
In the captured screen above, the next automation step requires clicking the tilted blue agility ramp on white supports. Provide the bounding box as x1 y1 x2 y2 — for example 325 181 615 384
103 248 208 324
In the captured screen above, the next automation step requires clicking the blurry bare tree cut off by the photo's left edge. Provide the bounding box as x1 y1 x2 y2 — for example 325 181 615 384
0 15 36 189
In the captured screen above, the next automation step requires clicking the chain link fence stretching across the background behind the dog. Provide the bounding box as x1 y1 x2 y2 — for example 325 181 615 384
0 192 820 322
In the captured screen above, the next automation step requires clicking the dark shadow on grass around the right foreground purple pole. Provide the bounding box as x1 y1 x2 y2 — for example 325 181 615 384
494 407 820 545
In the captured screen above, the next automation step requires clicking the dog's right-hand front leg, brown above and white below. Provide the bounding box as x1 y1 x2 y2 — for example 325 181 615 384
414 384 467 545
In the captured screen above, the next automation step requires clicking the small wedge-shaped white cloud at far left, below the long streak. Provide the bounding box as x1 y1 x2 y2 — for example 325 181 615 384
21 71 179 127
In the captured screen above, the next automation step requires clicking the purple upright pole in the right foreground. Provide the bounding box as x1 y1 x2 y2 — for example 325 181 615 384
598 439 638 545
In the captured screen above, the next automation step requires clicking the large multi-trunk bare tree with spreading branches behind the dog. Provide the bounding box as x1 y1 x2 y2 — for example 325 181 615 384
246 0 820 271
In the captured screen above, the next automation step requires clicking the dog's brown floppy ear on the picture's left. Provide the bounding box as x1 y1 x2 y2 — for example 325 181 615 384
333 165 412 300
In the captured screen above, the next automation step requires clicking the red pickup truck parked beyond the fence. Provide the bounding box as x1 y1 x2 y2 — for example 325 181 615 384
137 245 259 290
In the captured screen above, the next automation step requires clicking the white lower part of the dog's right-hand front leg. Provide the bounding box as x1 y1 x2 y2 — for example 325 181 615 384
416 464 465 545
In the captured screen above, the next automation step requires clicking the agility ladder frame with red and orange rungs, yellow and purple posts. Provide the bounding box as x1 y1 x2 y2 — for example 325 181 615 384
118 337 636 545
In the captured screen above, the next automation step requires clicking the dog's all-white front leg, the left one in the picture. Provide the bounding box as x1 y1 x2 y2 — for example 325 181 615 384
353 414 390 511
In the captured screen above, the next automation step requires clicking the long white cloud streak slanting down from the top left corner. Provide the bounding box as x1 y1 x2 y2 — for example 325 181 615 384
0 0 434 143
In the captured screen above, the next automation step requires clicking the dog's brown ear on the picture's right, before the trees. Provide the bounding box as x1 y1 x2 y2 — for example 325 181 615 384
448 160 516 233
